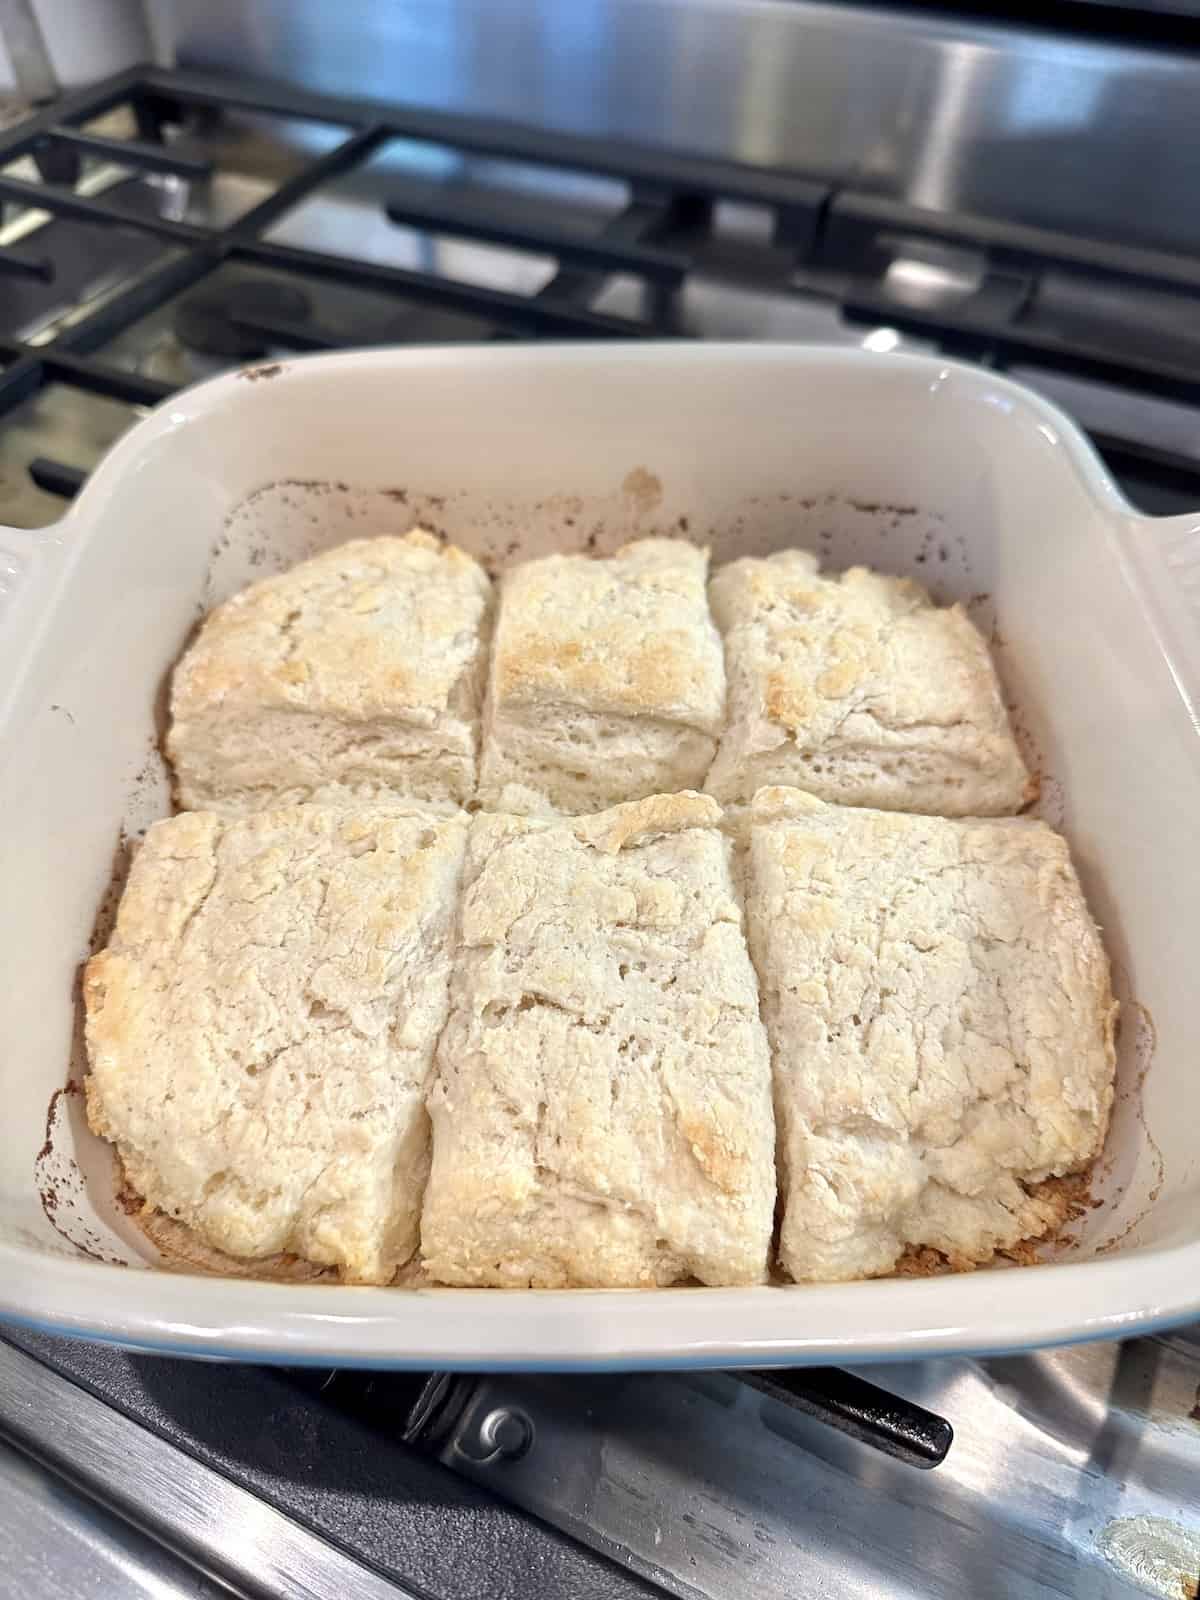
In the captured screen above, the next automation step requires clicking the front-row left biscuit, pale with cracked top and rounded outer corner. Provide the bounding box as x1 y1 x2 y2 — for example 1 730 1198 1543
83 806 467 1283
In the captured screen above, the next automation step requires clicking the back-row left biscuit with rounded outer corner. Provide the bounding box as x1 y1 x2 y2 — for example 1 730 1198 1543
168 528 491 813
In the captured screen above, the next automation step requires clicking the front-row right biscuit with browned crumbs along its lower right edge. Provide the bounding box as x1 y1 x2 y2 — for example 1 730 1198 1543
741 790 1117 1280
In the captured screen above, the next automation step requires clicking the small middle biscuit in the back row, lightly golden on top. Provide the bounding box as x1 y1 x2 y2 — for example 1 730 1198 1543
480 539 725 813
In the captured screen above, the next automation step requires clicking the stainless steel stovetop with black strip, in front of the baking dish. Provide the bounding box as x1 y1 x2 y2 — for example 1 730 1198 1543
0 1334 1200 1600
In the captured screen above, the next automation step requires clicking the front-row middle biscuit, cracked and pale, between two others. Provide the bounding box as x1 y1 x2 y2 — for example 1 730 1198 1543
421 794 774 1288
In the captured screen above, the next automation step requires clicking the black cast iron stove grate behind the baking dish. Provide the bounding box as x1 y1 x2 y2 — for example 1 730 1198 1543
0 66 1200 498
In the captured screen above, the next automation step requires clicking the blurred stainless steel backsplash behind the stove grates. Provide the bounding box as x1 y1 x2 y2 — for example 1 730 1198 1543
155 0 1200 248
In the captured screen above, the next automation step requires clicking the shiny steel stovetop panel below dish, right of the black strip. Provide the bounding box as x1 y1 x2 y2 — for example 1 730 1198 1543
443 1334 1200 1600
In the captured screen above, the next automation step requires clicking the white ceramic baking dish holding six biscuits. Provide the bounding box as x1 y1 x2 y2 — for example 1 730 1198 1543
0 344 1200 1368
